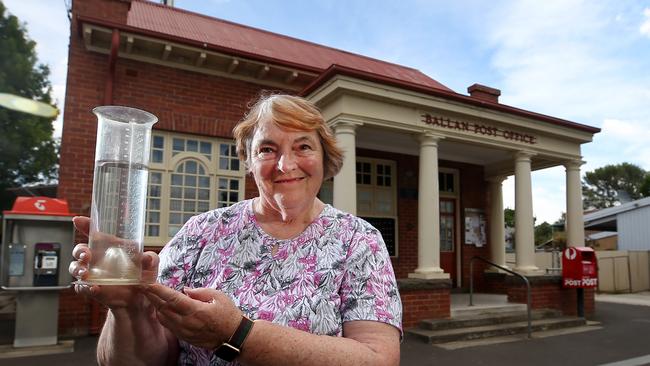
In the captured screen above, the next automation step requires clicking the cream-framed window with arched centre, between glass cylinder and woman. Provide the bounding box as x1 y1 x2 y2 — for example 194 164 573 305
145 131 245 245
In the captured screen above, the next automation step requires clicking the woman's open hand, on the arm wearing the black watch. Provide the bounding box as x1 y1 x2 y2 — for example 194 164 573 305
144 284 242 349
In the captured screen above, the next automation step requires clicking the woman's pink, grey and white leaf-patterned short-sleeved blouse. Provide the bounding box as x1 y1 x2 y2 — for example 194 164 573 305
158 200 402 365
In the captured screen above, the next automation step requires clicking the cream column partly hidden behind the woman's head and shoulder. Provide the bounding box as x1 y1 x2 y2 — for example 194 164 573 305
333 121 361 215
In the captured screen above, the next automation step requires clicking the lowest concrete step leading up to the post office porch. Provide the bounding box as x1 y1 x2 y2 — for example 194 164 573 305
406 317 586 344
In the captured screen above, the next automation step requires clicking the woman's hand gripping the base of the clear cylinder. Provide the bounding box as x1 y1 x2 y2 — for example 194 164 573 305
68 216 159 310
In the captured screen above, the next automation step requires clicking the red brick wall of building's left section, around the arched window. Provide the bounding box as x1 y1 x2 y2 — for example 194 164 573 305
58 0 282 335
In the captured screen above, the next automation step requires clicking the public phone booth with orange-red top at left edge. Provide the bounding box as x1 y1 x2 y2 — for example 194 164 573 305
0 197 74 347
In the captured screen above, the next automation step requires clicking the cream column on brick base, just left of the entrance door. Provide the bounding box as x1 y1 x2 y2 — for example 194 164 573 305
409 133 449 279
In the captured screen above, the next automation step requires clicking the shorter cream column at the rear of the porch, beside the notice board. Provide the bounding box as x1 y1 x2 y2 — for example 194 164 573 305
487 177 507 269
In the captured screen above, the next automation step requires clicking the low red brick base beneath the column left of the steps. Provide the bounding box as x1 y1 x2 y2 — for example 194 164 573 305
400 288 450 329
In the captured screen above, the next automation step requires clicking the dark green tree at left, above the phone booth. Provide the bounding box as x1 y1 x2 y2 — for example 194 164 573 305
0 1 58 209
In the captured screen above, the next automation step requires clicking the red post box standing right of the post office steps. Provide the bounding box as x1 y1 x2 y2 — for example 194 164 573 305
562 247 598 288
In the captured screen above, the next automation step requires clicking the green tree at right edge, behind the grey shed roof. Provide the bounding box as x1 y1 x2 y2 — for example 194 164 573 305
582 163 650 209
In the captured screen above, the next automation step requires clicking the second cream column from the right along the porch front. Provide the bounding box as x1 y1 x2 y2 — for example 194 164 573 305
515 151 539 274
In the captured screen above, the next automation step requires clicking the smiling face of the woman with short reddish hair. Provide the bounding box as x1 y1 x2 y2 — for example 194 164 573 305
250 121 323 217
